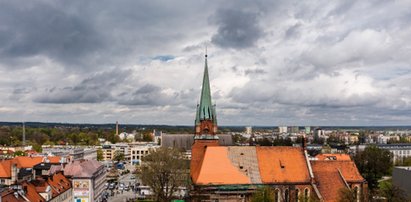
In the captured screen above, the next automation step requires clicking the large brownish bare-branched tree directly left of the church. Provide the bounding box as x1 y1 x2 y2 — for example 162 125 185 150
137 147 189 202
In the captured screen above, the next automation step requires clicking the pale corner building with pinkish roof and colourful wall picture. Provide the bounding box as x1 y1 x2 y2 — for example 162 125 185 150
64 159 106 202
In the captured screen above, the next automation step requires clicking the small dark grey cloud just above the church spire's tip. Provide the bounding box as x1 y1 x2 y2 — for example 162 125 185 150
211 9 263 49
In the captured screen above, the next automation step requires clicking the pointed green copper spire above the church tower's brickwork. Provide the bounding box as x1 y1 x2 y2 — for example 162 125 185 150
196 54 216 124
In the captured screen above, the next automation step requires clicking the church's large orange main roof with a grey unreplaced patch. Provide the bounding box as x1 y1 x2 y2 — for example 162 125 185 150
192 146 310 185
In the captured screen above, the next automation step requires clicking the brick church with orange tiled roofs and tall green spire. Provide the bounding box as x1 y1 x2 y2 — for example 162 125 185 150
190 55 367 202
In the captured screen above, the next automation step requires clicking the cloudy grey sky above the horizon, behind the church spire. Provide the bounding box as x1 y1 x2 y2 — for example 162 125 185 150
0 0 411 126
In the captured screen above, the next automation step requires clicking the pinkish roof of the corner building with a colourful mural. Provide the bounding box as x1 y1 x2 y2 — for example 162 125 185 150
64 160 104 178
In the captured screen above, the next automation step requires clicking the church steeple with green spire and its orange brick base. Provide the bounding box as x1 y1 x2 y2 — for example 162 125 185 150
195 52 217 135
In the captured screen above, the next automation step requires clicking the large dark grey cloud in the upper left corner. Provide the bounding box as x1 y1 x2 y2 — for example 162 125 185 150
0 1 103 67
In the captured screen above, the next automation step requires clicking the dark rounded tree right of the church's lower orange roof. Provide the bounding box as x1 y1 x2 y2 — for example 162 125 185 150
354 146 392 191
